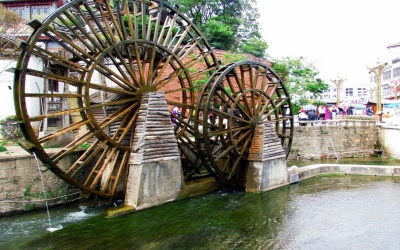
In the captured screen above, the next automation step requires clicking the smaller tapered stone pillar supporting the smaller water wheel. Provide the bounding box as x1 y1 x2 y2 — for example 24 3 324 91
246 121 289 192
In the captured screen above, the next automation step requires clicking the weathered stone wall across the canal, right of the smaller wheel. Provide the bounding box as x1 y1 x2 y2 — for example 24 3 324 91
289 120 380 159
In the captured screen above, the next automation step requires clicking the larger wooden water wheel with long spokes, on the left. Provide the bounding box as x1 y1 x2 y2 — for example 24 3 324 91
14 0 219 198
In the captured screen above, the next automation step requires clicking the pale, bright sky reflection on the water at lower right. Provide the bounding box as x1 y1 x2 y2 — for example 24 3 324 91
277 176 400 249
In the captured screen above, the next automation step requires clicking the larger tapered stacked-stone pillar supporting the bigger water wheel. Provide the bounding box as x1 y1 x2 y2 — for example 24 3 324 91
125 92 184 210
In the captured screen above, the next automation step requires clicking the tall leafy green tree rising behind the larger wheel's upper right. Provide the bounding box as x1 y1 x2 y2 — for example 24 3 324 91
169 0 268 57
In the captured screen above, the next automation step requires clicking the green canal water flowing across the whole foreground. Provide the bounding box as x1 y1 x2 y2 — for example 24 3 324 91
0 159 400 249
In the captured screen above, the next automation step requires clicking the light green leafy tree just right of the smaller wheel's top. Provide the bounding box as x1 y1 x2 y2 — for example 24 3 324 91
273 57 329 105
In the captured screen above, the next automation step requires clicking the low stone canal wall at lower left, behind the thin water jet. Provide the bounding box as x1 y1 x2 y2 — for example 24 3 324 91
0 147 80 216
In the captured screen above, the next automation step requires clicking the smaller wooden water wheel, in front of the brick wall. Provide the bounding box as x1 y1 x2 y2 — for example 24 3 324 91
195 61 293 188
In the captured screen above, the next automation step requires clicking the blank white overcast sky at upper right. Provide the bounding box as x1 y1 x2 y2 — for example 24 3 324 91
257 0 400 85
